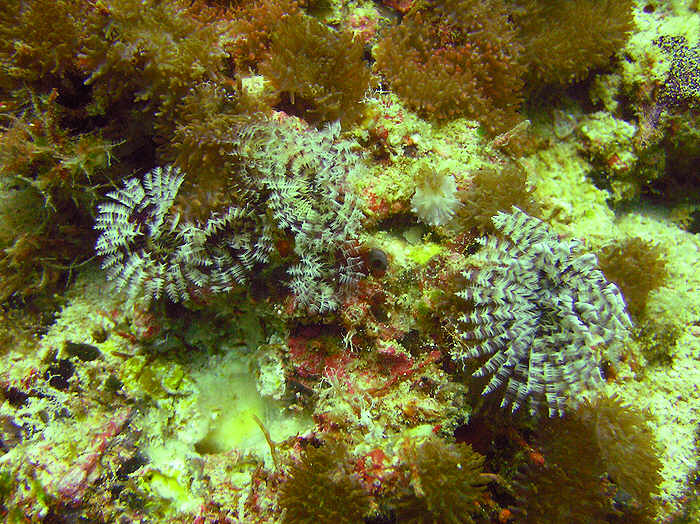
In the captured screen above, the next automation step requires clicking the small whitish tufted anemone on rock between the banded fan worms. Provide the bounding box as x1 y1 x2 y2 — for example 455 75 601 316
411 160 461 226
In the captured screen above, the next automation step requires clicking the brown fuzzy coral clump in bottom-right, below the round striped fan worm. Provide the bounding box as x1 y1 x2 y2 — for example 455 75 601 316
518 397 661 524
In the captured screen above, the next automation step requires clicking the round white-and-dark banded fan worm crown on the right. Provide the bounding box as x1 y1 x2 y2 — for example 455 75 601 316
454 207 632 416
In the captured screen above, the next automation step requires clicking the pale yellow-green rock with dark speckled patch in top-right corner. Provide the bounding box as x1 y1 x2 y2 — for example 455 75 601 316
591 4 700 204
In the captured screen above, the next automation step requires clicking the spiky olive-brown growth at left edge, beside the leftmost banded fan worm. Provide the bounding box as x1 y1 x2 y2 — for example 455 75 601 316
0 97 112 300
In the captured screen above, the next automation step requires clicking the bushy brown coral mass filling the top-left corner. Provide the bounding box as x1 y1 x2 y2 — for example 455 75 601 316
0 0 235 160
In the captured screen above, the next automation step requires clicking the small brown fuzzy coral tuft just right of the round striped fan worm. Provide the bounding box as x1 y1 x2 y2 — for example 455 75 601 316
598 237 668 318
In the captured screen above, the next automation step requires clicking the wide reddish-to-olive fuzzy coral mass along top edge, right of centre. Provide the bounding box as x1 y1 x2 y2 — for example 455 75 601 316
375 0 633 129
